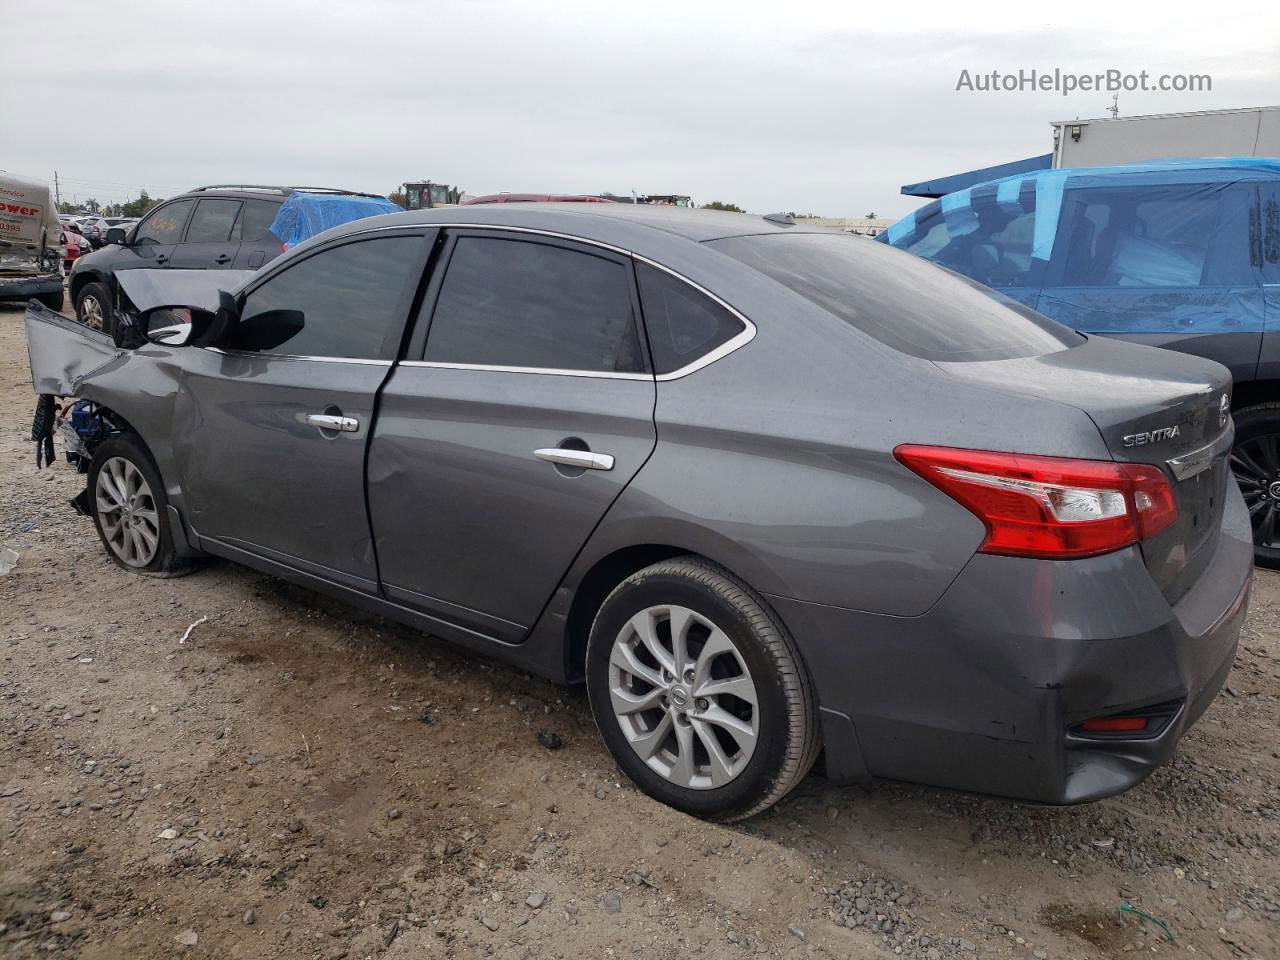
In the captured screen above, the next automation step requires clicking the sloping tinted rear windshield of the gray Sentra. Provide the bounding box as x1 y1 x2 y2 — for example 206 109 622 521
708 233 1084 361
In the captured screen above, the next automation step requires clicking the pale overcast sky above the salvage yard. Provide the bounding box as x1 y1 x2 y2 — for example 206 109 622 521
0 0 1280 216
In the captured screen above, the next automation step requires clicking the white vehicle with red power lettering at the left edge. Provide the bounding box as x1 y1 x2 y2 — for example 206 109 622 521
0 172 63 310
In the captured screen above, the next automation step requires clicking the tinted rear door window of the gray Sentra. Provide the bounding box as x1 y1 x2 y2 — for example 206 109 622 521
426 237 644 372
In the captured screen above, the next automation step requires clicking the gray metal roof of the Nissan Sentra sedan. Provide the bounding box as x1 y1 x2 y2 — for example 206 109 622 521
321 204 844 250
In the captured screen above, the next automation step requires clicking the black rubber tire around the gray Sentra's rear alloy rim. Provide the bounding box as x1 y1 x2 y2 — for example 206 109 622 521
586 557 820 822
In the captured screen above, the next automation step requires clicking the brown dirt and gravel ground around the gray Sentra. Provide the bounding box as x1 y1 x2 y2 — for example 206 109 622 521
0 300 1280 960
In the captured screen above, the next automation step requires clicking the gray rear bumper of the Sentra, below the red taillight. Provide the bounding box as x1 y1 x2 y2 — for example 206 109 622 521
771 483 1253 804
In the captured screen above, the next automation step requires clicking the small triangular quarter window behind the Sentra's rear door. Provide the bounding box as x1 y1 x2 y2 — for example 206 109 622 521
636 264 746 374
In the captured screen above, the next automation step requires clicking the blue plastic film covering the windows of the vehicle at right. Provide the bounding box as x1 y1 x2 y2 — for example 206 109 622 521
879 156 1280 337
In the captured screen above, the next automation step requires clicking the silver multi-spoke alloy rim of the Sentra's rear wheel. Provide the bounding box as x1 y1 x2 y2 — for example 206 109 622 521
609 605 759 790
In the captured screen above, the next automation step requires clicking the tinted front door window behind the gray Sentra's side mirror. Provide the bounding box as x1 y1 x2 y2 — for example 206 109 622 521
229 237 422 360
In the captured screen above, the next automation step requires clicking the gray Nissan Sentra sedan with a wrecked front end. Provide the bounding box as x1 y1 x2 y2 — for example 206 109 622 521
27 204 1253 819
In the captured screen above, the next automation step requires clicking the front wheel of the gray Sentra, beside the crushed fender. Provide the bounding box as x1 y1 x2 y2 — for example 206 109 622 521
88 434 188 576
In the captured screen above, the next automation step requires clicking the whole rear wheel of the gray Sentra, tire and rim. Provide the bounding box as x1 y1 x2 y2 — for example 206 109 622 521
586 557 819 820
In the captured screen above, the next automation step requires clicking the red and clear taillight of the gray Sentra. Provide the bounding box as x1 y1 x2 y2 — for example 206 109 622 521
893 444 1178 559
